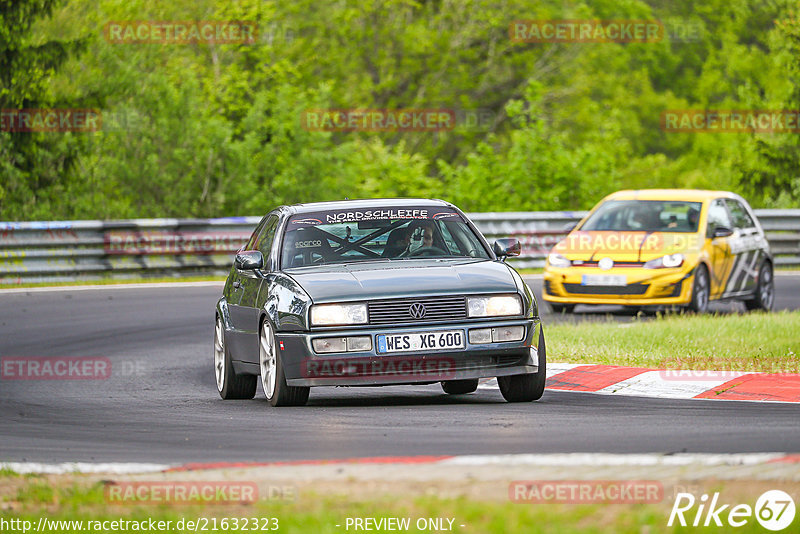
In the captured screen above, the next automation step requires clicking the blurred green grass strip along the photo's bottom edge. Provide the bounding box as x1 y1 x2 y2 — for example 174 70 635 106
0 478 776 534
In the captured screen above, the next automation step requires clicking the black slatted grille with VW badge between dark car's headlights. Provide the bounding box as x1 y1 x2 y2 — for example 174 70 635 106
367 297 467 324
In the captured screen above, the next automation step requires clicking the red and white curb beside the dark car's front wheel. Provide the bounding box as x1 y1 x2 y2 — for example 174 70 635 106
478 363 800 402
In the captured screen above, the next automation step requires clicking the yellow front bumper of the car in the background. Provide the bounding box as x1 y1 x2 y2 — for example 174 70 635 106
542 266 694 306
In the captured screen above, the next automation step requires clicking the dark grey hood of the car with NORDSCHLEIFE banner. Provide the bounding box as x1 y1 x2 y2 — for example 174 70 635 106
285 259 517 303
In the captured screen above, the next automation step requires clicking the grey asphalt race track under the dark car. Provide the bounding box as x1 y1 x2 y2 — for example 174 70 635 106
0 274 800 463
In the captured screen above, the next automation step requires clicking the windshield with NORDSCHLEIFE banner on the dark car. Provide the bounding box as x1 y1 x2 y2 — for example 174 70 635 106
281 207 490 269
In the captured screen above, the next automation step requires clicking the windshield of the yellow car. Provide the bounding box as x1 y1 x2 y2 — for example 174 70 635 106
580 200 701 233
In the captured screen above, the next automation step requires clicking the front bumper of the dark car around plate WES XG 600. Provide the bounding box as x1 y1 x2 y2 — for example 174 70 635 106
276 319 540 386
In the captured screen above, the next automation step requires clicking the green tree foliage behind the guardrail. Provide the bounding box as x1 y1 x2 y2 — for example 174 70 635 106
0 0 800 220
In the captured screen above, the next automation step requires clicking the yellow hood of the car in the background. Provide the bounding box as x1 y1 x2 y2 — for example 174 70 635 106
552 231 702 262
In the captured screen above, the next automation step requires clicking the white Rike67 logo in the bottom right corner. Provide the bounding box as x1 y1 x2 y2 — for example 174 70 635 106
667 490 796 532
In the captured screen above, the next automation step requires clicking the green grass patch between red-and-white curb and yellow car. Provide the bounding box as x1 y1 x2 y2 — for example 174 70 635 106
545 312 800 373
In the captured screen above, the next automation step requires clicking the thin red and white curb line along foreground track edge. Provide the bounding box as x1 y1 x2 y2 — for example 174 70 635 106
0 453 800 475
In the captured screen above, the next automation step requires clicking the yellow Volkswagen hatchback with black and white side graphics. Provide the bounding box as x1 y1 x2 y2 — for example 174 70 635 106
542 189 775 313
